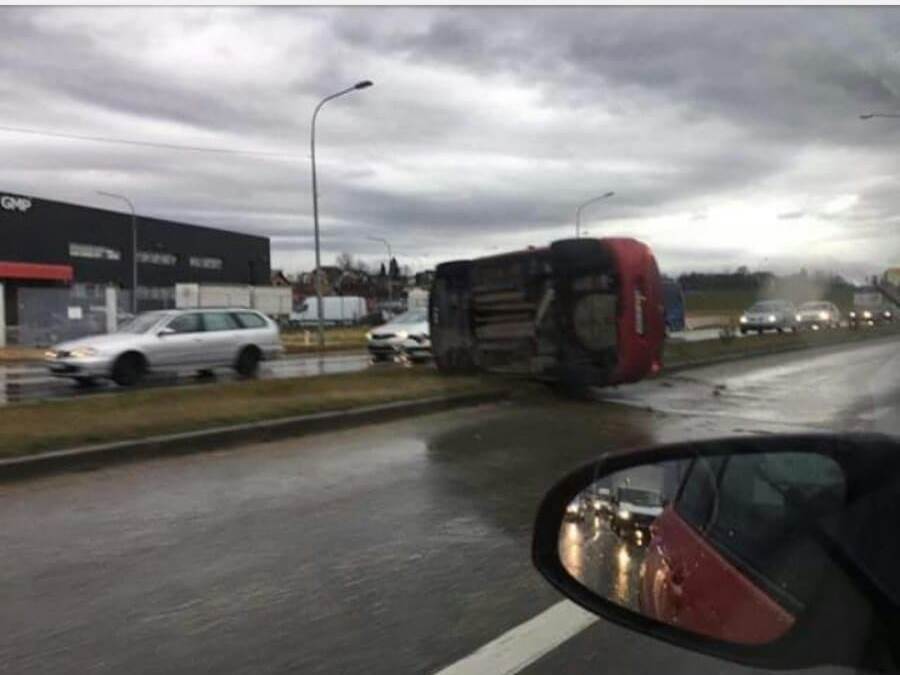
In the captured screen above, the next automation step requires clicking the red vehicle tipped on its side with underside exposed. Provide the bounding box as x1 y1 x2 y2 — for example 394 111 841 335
429 238 665 386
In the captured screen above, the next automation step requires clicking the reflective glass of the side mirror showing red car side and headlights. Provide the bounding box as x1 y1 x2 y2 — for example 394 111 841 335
559 453 846 644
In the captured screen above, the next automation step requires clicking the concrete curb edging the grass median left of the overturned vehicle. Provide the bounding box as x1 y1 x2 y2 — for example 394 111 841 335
0 390 511 483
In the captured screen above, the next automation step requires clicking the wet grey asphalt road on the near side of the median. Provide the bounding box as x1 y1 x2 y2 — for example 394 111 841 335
0 340 900 675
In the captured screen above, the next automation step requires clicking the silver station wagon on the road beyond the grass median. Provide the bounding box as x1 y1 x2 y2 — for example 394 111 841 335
45 309 284 386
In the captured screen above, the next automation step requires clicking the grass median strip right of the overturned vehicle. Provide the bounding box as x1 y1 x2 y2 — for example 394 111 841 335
664 324 900 368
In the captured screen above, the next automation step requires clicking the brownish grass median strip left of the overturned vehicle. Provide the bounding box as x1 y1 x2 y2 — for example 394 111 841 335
0 369 504 457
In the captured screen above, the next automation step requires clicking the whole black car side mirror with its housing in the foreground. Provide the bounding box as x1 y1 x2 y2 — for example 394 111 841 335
532 435 900 669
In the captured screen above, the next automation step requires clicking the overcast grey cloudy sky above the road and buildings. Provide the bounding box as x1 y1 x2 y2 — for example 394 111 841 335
0 7 900 277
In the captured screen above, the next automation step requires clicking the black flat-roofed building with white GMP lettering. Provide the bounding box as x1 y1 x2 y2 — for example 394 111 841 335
0 193 270 323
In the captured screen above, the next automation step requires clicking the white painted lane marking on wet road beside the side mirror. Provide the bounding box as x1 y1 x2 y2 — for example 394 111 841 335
435 600 598 675
